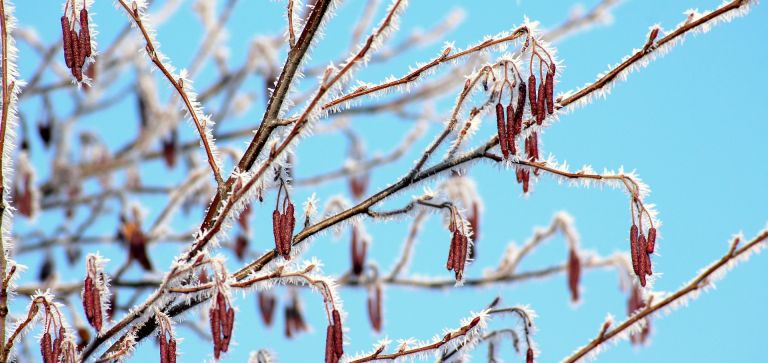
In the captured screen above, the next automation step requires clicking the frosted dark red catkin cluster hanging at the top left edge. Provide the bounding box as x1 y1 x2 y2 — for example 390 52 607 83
61 1 92 82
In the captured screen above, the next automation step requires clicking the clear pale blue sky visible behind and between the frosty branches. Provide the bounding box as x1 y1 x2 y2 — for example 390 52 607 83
7 0 768 362
